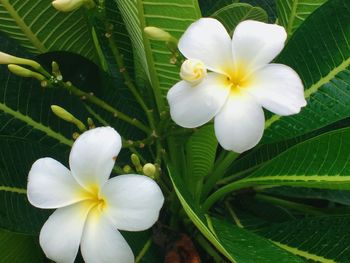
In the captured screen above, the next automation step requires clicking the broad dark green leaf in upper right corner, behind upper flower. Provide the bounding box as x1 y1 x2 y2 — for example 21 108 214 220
263 0 350 143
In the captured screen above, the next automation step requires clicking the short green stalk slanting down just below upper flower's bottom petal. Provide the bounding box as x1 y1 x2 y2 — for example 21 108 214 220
202 152 239 201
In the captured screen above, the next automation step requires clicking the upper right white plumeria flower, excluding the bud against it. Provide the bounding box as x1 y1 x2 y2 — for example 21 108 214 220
167 18 306 153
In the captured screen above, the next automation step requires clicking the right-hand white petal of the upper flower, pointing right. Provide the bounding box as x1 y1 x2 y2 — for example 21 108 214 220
247 64 306 115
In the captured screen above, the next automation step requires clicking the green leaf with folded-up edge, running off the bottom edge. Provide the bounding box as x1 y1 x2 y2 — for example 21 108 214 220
169 168 303 263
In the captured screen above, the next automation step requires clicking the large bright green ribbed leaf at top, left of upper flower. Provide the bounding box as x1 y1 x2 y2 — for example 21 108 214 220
117 0 200 111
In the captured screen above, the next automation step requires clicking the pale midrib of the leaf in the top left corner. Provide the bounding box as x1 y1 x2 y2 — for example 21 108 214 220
0 0 47 53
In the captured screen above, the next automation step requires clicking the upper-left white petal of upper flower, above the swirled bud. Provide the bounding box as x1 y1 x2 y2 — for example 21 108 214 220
178 18 232 74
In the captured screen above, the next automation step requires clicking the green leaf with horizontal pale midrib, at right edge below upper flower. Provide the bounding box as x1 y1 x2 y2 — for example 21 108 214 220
245 128 350 190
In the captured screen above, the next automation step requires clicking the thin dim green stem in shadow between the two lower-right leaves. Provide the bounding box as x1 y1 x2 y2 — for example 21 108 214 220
255 194 324 215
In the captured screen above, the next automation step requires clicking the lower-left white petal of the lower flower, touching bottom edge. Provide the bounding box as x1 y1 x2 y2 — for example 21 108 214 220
39 202 90 263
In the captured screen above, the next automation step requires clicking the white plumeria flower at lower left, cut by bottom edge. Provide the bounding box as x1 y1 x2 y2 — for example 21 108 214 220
28 127 164 263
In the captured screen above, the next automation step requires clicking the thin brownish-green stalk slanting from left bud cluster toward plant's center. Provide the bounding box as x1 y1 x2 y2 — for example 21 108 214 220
59 82 152 134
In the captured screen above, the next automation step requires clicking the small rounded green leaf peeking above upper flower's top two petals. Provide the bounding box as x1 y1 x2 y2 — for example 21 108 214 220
212 3 267 35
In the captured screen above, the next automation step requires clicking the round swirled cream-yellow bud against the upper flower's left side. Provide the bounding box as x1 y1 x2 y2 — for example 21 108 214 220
180 59 207 85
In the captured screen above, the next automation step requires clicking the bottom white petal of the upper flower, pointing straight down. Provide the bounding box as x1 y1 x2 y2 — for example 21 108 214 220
214 94 265 153
